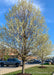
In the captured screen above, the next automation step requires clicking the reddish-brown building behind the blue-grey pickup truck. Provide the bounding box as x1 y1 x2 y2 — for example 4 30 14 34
0 47 18 59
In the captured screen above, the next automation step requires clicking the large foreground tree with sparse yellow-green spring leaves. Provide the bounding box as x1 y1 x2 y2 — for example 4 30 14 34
0 0 46 74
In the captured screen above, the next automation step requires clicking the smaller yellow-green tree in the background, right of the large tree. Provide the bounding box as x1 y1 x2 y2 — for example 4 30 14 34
35 34 53 66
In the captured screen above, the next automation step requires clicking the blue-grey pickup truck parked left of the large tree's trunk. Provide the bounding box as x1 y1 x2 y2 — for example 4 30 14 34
0 58 21 67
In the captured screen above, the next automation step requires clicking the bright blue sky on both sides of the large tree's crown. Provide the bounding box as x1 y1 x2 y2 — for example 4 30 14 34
0 0 54 55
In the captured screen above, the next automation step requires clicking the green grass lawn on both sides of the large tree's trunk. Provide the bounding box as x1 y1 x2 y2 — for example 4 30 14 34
5 65 54 75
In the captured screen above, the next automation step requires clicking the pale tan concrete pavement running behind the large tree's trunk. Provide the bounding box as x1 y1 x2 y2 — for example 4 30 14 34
0 64 39 75
